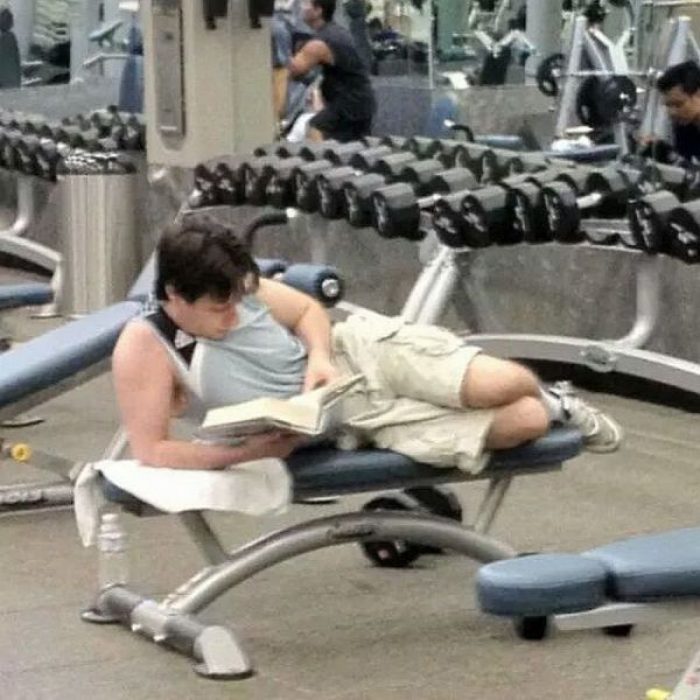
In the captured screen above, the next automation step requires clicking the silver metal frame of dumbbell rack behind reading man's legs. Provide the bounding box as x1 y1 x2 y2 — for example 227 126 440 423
402 239 700 395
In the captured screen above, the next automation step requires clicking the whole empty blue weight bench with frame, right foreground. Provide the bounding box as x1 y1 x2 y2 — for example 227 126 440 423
477 528 700 640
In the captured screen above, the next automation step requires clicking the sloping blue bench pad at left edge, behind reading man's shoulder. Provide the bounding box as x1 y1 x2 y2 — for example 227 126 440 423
0 301 141 408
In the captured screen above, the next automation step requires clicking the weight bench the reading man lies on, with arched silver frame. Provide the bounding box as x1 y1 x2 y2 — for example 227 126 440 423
83 428 582 679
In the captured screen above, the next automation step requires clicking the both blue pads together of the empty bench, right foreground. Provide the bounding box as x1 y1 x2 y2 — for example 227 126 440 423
477 528 700 617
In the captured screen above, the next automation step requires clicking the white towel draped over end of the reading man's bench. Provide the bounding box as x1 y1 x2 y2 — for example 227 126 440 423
74 459 292 547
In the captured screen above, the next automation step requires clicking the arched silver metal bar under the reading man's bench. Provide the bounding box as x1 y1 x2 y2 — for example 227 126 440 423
168 511 516 614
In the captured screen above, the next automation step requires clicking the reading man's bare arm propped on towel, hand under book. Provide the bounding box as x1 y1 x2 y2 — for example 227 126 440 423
112 323 298 469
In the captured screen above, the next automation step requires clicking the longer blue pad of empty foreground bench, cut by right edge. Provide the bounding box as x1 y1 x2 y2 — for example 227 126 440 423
584 527 700 602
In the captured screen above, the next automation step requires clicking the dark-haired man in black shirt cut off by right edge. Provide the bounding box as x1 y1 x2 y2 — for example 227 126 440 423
656 61 700 160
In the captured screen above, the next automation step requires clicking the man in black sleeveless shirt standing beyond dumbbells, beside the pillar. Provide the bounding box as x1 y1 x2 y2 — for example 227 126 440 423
289 0 376 141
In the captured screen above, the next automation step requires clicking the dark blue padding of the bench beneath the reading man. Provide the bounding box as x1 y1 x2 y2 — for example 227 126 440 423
103 428 582 514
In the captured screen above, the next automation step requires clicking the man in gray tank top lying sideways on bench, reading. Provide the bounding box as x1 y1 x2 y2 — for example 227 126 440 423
113 217 621 472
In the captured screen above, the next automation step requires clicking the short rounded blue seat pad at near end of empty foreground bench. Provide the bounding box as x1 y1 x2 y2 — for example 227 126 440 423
476 554 606 617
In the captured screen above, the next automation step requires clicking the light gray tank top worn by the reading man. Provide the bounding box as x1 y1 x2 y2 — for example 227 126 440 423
190 295 306 410
